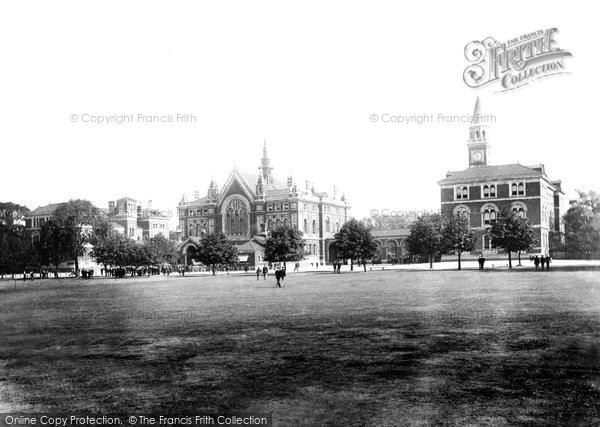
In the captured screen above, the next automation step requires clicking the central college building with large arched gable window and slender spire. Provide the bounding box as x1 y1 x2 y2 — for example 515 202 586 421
177 144 350 266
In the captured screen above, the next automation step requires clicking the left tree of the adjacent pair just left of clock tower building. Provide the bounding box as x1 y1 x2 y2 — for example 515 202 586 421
406 214 446 268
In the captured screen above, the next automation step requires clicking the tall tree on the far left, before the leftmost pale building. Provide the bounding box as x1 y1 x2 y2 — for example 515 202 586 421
52 199 100 277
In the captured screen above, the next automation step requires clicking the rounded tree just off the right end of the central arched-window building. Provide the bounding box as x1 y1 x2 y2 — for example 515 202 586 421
335 218 377 271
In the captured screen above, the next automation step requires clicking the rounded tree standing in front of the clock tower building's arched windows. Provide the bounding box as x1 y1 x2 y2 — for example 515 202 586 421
489 208 537 268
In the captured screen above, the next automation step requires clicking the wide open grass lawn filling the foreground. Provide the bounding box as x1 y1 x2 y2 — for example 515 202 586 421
0 271 600 425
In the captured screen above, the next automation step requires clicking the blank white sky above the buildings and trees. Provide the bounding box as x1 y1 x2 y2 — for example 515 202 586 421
0 0 600 227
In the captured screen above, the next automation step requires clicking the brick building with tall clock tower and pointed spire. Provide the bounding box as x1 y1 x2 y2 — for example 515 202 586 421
438 98 567 256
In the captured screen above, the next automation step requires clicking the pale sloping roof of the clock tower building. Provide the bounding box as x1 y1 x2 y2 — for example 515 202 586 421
438 164 544 185
